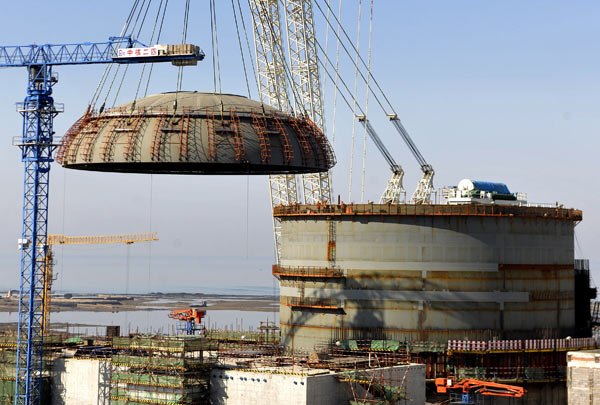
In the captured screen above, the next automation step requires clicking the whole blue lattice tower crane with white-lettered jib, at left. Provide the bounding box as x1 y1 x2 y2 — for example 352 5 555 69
0 36 204 405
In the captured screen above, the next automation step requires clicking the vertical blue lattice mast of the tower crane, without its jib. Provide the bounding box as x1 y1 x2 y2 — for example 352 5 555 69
15 65 59 405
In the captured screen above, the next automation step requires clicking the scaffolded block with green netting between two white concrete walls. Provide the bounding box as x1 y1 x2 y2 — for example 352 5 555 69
110 336 216 405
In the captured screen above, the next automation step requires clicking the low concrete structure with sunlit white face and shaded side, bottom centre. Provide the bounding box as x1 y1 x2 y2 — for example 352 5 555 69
210 364 425 405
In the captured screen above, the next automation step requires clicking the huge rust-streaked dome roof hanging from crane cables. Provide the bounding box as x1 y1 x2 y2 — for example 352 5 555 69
56 92 335 174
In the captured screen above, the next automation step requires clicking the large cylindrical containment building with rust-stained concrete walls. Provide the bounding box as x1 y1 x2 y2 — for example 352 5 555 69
273 204 582 350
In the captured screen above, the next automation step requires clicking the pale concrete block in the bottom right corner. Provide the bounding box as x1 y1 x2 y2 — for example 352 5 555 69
567 350 600 405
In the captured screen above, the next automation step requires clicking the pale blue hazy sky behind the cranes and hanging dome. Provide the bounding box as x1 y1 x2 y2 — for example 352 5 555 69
0 0 600 292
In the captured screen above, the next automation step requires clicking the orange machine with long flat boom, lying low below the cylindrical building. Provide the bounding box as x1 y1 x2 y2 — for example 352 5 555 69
435 377 527 404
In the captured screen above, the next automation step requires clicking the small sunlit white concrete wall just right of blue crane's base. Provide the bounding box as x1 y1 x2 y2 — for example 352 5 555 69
51 359 110 405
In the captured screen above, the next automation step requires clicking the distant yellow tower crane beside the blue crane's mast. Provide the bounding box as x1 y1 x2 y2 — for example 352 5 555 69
42 232 158 334
